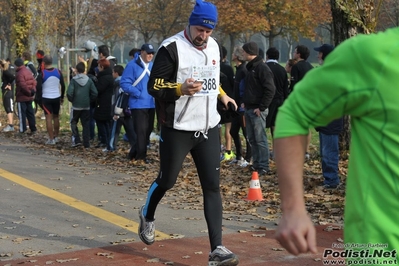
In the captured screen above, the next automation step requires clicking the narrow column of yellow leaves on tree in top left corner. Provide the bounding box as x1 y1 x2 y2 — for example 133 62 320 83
10 0 32 57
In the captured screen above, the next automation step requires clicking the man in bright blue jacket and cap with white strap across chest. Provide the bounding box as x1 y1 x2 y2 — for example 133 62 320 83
120 43 155 162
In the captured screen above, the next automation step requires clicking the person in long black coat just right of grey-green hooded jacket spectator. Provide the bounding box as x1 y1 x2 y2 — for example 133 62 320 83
94 58 114 151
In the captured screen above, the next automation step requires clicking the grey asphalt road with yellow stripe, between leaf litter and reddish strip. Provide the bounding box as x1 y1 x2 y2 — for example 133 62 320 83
0 135 275 261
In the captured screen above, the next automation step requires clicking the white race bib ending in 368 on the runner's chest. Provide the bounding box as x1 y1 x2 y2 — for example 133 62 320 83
192 66 219 96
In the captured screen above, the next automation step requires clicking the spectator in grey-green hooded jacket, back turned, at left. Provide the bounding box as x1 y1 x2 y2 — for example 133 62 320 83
67 62 98 148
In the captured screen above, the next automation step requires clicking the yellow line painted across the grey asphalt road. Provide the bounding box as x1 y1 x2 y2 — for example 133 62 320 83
0 168 170 240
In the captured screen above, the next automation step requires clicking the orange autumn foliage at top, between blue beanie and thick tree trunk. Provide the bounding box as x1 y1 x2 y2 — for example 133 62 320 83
215 0 331 60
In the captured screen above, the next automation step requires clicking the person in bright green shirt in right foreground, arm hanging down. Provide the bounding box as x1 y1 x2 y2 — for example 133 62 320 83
275 27 399 265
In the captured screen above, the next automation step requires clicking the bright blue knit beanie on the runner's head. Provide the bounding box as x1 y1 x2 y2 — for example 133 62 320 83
189 0 218 29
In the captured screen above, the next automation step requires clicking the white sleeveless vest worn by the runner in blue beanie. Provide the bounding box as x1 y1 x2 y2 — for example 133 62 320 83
161 31 220 135
